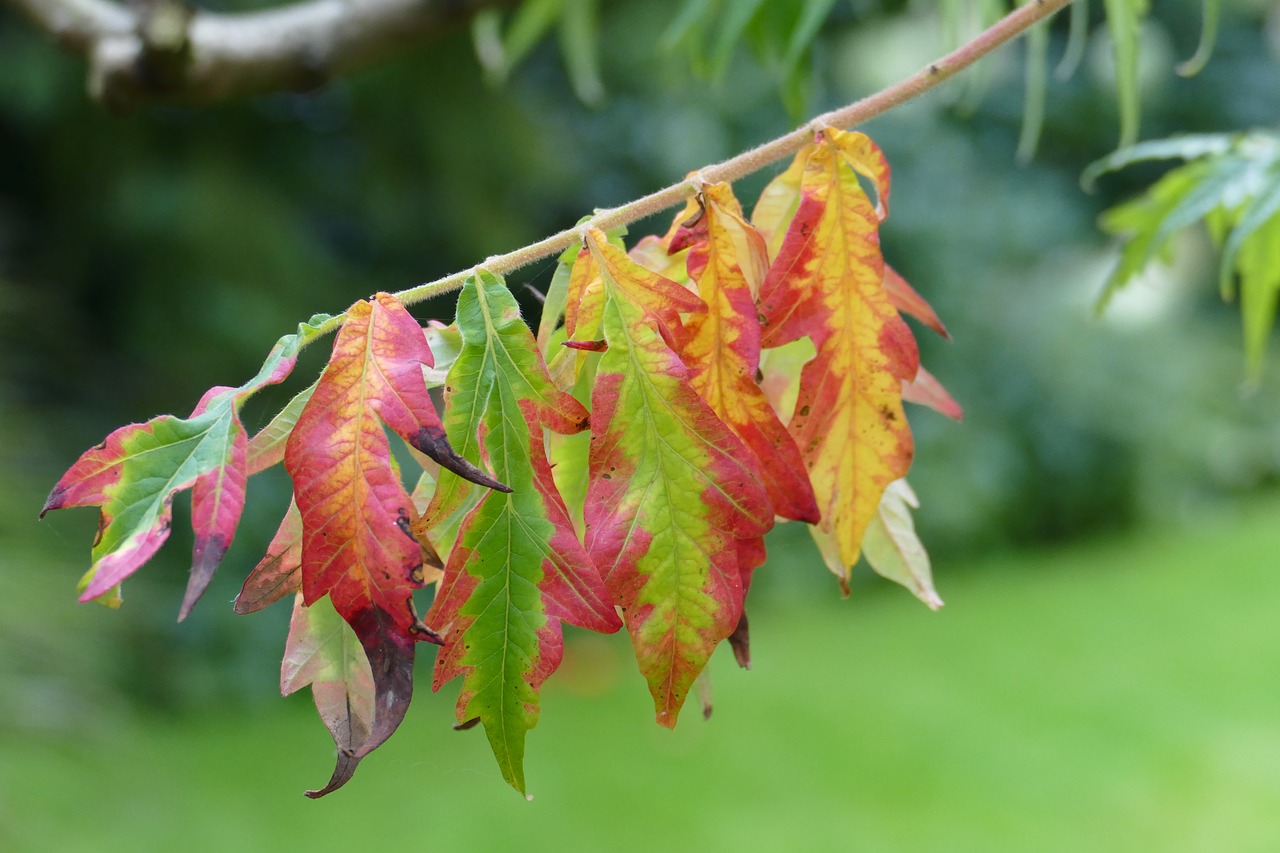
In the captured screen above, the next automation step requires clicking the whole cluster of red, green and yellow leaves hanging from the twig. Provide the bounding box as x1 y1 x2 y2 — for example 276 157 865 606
45 129 960 797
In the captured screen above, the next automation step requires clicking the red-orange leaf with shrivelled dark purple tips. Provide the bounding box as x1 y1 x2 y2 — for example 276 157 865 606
284 293 507 797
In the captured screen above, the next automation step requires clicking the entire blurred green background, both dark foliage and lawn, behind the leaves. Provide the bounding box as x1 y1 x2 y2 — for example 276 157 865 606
0 0 1280 850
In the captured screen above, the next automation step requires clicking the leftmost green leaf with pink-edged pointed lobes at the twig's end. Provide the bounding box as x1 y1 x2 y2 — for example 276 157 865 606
41 315 330 620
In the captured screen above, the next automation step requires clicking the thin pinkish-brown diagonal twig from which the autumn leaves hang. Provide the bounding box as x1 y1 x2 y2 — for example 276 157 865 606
394 0 1074 304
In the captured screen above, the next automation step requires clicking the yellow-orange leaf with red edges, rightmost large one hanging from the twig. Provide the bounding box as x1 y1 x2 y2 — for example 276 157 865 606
759 129 919 580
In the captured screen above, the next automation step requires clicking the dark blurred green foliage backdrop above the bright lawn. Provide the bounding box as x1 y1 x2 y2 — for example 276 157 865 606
0 0 1280 726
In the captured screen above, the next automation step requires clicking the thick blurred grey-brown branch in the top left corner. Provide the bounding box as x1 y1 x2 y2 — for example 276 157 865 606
0 0 502 111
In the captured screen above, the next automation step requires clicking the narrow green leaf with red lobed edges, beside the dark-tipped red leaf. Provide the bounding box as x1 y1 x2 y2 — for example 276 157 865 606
425 272 621 793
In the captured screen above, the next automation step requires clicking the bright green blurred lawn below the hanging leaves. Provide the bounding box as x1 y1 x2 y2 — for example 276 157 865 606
0 501 1280 852
